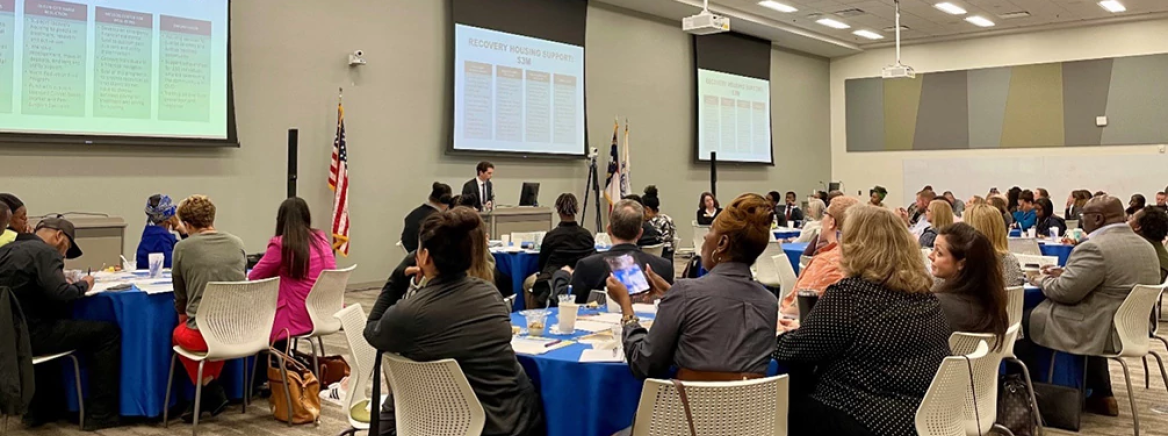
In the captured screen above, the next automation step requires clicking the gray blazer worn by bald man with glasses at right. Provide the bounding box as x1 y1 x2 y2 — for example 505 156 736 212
1030 226 1160 355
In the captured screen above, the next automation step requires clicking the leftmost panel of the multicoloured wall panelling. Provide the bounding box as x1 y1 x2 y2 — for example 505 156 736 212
843 78 884 152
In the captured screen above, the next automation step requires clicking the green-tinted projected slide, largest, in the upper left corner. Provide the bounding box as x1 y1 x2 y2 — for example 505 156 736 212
0 0 228 139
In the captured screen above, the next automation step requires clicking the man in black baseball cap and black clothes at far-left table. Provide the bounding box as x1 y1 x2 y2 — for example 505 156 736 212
0 217 121 430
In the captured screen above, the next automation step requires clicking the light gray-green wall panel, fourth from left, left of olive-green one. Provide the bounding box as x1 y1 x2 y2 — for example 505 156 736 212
966 68 1010 148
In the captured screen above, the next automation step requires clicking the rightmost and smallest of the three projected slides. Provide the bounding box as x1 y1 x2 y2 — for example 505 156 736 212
697 69 771 164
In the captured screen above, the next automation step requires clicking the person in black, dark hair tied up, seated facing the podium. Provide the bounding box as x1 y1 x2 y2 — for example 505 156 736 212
527 193 596 307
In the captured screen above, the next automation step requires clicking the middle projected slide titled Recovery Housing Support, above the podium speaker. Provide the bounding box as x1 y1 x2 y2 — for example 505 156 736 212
453 25 584 155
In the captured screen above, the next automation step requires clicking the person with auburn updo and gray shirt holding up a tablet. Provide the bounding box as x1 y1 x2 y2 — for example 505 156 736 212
607 194 778 381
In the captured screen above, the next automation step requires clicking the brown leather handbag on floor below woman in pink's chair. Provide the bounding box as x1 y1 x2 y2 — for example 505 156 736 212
267 331 320 424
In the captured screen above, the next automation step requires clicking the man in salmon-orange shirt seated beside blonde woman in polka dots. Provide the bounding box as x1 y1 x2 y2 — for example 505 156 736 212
779 196 860 316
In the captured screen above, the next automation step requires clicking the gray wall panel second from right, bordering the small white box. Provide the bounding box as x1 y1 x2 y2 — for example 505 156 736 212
1063 58 1113 145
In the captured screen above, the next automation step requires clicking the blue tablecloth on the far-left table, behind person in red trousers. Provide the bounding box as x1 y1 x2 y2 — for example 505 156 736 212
64 289 251 417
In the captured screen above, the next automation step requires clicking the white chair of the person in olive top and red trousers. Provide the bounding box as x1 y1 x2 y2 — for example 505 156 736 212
162 277 282 434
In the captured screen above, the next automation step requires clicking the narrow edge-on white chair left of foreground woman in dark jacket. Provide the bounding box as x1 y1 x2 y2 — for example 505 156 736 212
333 304 381 436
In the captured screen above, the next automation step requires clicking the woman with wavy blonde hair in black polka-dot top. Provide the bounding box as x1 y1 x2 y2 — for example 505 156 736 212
773 207 950 436
